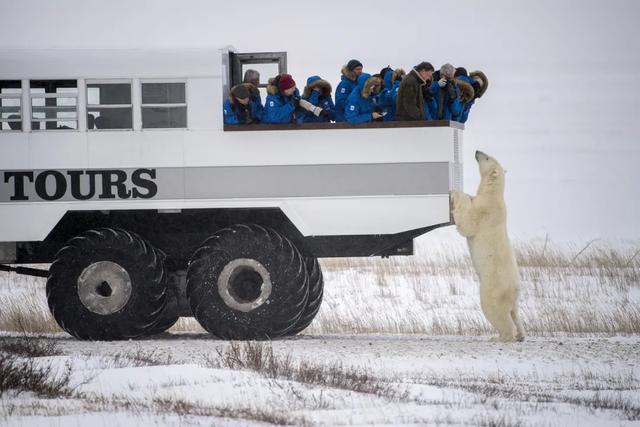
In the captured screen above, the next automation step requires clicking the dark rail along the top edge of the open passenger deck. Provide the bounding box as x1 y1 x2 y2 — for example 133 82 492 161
224 120 464 132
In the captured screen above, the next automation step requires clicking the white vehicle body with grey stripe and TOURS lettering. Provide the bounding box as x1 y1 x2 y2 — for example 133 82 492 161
0 48 463 262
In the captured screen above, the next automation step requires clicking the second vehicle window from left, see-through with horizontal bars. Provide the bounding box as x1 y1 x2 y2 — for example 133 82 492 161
30 80 78 130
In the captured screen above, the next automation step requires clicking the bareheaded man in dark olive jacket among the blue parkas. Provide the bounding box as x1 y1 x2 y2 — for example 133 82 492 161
396 62 433 120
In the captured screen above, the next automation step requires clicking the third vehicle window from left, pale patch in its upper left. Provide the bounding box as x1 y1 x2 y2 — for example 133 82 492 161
87 81 133 130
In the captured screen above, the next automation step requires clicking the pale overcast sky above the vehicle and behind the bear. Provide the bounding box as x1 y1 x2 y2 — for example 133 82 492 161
0 0 640 241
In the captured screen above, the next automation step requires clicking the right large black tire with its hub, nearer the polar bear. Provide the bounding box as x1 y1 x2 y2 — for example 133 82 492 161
187 225 308 340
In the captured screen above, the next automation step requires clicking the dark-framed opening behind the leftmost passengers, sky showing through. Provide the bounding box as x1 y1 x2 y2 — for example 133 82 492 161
225 52 287 100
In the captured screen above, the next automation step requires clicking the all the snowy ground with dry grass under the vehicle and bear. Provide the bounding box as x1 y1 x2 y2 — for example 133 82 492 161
0 239 640 427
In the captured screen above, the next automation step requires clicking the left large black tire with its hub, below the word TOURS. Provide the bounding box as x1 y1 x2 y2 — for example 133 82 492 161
47 228 166 340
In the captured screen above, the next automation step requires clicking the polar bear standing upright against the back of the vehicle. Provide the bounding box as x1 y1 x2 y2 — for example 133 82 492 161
451 151 524 341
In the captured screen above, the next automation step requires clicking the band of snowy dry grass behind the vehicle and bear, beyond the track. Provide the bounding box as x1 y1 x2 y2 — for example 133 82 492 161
0 242 640 336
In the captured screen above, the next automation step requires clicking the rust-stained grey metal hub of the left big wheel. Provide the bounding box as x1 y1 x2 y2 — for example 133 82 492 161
78 261 131 315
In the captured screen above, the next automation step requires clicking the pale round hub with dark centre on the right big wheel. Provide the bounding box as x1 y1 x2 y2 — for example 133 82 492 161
218 258 272 313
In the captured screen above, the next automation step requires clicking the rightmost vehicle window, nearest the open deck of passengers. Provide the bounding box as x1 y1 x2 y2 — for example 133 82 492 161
142 82 187 129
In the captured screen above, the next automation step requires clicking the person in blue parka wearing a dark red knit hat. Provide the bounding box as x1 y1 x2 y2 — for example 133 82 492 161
262 74 304 124
